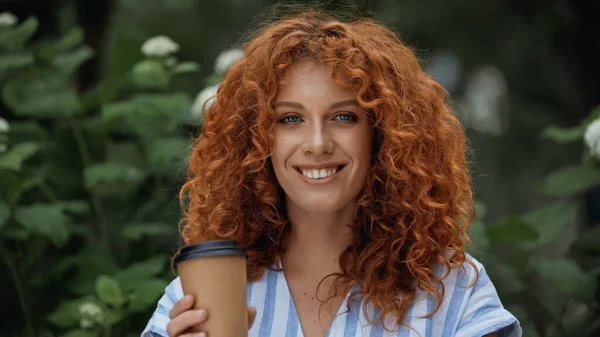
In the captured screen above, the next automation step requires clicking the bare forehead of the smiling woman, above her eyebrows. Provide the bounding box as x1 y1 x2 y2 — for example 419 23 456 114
277 59 356 101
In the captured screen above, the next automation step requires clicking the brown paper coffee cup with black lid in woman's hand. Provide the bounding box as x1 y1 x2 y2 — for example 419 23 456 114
173 240 248 337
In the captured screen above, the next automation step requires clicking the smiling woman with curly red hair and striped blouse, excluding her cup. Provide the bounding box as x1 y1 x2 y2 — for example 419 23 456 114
142 7 521 337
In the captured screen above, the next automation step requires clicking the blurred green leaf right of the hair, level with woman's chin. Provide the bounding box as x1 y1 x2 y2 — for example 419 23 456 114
523 202 577 245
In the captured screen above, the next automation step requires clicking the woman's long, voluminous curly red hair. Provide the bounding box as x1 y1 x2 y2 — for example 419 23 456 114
180 11 474 325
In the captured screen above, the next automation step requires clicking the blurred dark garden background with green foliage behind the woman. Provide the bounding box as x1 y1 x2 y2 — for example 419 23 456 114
0 0 600 337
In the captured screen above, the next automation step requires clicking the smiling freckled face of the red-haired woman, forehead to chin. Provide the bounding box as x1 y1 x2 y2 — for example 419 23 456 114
271 60 372 213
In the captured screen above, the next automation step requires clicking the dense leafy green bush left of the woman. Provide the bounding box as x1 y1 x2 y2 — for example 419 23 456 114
0 18 199 337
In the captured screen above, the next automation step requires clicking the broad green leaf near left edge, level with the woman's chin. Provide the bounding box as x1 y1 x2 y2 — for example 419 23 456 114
14 204 69 247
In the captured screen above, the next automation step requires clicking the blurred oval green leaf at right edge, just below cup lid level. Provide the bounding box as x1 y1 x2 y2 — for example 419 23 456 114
532 258 596 303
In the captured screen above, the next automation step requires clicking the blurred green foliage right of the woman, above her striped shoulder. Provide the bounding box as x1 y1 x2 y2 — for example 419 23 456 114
470 109 600 337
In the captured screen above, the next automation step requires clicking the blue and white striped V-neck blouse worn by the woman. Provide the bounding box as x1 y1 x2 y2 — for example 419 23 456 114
141 256 522 337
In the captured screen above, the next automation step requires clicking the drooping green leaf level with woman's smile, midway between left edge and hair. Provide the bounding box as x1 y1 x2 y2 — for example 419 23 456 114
83 162 144 189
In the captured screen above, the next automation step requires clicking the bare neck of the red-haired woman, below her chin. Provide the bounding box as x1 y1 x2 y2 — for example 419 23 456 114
282 197 356 277
